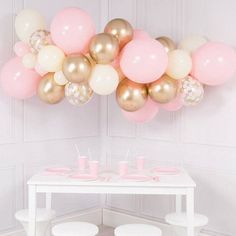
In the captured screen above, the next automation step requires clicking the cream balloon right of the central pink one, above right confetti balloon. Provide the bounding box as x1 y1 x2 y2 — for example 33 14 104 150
166 49 192 79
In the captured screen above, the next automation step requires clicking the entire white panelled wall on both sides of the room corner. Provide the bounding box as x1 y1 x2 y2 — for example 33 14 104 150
0 0 236 236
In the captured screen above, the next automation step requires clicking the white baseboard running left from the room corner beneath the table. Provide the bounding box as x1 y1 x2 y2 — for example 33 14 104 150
0 208 102 236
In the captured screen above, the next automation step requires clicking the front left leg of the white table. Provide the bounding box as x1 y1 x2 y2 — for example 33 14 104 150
28 185 37 236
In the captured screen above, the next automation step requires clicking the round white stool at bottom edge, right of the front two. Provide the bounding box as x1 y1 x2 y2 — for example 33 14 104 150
115 224 162 236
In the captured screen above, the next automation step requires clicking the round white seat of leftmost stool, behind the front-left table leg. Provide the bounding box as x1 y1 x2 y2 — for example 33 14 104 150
15 208 56 222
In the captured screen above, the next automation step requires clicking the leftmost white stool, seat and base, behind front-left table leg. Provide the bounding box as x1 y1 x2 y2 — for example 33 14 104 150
15 208 56 236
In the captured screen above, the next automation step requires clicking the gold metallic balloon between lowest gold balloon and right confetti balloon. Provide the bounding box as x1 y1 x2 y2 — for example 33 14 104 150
148 75 178 103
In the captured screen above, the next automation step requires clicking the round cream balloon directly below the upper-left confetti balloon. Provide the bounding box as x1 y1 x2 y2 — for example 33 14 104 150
38 45 65 72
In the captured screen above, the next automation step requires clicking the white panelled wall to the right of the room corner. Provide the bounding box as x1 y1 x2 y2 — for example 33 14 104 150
105 0 236 236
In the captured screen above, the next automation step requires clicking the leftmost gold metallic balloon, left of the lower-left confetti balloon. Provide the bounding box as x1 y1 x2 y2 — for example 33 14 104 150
38 73 65 104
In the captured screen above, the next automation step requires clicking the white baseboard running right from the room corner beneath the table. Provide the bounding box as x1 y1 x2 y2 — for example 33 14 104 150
103 209 213 236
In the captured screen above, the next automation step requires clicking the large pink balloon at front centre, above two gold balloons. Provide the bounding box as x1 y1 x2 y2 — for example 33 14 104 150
120 38 168 83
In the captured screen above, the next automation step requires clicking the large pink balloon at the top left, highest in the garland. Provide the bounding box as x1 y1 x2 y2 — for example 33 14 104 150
51 8 95 54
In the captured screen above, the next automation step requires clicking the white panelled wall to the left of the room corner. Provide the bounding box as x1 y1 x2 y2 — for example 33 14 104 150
0 0 103 233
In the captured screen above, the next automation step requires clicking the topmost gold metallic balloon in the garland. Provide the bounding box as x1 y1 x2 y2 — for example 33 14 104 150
104 18 133 48
